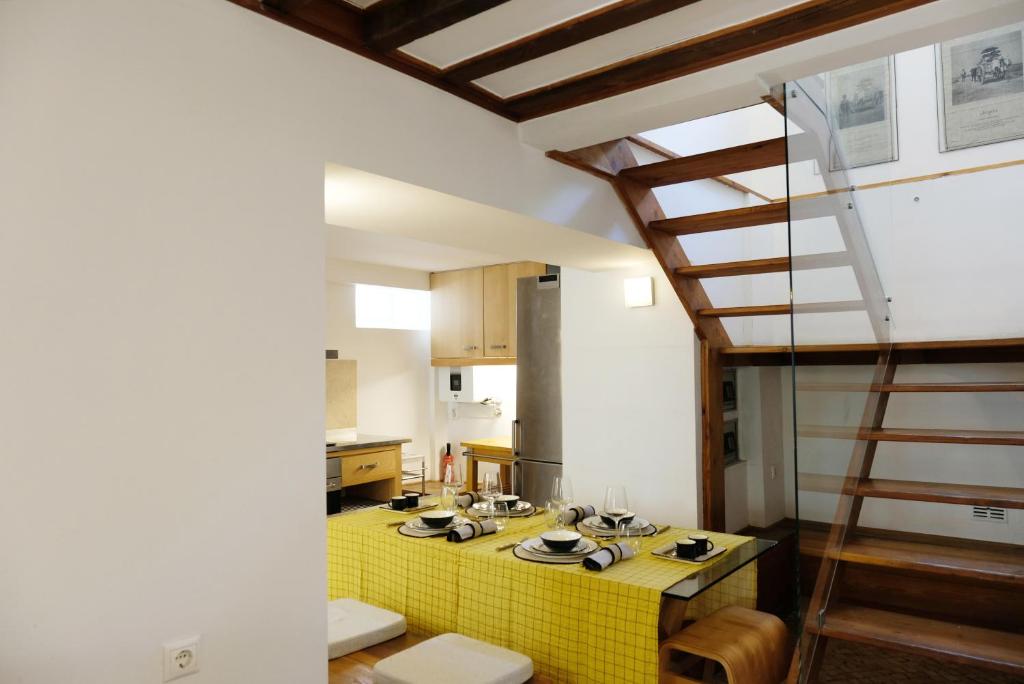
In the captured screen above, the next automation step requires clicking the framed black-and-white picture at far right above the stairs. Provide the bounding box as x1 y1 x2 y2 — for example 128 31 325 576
936 25 1024 152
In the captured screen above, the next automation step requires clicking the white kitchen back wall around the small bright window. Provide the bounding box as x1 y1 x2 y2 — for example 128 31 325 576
325 260 433 456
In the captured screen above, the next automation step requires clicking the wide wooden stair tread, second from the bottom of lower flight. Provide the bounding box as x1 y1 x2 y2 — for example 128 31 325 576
839 535 1024 585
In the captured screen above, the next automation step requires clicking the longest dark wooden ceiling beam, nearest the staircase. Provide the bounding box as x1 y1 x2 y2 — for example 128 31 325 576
505 0 935 120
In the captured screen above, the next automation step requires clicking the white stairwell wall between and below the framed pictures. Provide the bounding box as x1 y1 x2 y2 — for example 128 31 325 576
790 41 1024 344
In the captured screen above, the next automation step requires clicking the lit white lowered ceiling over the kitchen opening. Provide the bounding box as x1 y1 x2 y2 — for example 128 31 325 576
324 164 652 270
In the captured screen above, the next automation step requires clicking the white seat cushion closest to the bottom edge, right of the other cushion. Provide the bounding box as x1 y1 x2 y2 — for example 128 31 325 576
374 634 534 684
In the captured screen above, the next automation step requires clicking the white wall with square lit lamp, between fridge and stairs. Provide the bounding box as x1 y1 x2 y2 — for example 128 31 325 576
561 262 699 526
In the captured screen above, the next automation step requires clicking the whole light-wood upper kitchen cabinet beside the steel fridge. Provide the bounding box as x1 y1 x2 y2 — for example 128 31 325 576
430 261 547 366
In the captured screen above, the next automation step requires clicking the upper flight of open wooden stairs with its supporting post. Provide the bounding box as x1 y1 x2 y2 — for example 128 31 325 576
548 127 868 529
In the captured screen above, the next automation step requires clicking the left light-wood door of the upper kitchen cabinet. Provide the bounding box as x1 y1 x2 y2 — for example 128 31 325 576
430 268 483 358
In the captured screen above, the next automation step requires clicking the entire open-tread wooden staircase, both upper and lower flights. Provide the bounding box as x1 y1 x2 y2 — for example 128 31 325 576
548 104 1024 681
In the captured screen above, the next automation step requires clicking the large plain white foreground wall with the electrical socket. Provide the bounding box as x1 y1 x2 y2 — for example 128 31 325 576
0 0 647 684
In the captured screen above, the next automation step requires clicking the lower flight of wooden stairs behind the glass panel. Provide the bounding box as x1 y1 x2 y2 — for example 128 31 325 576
798 356 1024 681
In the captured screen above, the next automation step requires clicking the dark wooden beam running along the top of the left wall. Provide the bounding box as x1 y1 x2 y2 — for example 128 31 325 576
228 0 515 121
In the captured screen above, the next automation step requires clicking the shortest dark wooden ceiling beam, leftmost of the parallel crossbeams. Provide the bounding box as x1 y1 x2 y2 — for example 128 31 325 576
365 0 516 52
